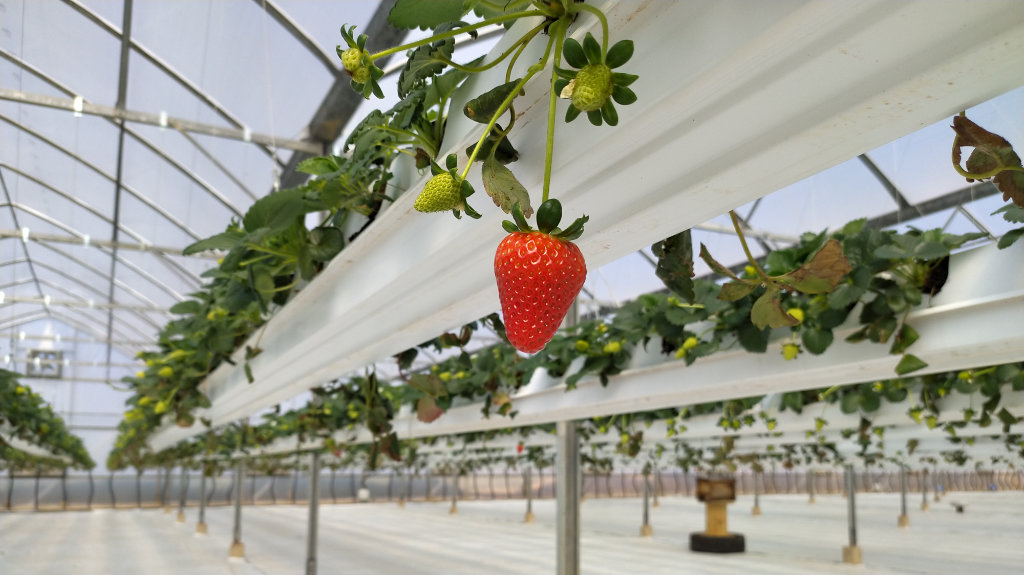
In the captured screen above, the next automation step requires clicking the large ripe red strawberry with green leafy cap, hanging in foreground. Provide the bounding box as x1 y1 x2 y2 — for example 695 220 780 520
495 200 587 353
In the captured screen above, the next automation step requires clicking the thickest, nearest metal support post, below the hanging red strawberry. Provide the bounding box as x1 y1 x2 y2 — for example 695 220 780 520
555 415 580 575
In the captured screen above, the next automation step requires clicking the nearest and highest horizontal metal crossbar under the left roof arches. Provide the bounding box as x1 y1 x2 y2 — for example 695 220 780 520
0 88 323 153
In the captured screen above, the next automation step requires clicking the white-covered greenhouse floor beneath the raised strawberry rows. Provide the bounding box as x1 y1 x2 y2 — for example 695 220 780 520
0 492 1024 575
